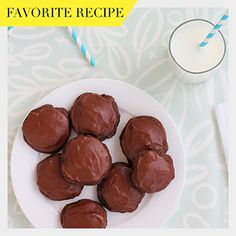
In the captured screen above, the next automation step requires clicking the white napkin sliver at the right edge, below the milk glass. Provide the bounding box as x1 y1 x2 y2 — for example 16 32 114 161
215 102 229 166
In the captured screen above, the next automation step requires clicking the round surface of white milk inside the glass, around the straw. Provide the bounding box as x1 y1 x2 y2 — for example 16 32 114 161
171 21 225 73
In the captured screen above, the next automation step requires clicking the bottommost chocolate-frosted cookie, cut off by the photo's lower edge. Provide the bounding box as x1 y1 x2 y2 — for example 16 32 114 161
61 199 107 228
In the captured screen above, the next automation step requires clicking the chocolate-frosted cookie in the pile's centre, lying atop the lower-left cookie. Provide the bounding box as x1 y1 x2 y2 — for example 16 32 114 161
61 135 112 185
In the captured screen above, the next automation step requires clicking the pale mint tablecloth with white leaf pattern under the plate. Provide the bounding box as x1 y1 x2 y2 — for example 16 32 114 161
8 9 228 228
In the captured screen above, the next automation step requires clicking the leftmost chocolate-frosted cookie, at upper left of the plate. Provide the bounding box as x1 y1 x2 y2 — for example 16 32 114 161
22 104 70 153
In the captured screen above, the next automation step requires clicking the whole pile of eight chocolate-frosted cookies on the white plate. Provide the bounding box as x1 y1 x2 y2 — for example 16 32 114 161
22 93 174 228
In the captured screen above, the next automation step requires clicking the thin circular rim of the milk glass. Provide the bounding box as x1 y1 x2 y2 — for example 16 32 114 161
168 18 226 75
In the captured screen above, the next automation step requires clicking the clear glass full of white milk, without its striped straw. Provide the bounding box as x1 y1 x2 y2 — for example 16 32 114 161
169 19 226 84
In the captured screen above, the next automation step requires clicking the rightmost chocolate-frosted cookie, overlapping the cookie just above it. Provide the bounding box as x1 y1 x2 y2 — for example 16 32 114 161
132 150 175 193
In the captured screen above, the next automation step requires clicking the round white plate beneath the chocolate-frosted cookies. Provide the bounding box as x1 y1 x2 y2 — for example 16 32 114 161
11 79 185 228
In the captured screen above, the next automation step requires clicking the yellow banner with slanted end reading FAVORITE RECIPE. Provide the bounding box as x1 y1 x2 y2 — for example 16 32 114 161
0 0 137 26
